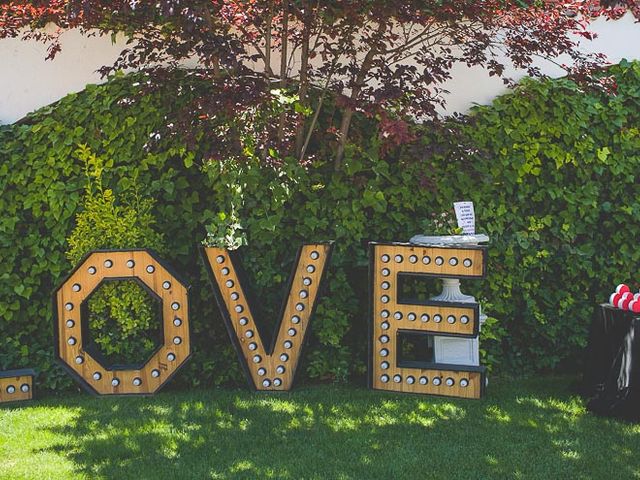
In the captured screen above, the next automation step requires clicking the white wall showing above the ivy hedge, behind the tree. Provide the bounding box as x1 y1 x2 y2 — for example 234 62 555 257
0 14 640 124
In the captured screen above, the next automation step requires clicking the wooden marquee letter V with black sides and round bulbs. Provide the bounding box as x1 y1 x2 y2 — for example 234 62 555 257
203 243 333 390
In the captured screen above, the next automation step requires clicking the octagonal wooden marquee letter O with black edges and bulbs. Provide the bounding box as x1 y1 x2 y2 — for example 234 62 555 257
53 249 191 395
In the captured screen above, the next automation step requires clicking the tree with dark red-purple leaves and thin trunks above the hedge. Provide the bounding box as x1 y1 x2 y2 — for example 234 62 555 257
0 0 640 170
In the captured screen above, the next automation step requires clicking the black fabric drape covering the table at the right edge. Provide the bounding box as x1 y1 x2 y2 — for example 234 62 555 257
583 305 640 421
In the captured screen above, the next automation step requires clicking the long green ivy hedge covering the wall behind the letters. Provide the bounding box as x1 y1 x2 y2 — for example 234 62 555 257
0 62 640 389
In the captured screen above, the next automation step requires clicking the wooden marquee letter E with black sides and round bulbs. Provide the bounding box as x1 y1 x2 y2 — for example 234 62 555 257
369 243 487 398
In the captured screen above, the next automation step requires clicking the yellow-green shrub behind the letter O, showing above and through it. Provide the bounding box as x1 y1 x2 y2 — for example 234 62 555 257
67 145 164 364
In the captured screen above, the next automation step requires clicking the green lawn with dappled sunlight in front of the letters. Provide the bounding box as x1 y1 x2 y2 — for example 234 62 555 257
0 377 640 480
